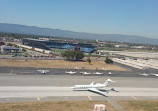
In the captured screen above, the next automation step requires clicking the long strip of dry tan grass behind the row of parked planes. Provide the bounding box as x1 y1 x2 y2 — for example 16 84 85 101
0 59 127 71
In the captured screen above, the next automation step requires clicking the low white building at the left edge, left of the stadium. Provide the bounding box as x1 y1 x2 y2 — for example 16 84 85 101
1 45 20 53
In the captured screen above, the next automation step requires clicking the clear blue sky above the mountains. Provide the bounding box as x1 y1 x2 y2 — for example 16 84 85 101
0 0 158 38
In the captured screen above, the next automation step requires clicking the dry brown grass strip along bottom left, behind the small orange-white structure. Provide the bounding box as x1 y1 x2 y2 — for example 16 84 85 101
0 101 117 111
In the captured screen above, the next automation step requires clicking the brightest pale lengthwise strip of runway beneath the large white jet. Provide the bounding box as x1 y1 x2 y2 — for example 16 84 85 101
0 86 158 98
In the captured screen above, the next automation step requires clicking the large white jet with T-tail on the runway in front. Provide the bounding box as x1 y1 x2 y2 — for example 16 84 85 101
71 79 118 96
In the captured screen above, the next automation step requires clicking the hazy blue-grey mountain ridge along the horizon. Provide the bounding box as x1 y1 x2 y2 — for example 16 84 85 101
0 23 158 45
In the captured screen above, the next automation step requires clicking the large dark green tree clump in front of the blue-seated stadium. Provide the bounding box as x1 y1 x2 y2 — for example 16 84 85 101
62 50 84 61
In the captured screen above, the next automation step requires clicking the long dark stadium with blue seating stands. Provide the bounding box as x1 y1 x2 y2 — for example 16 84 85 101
22 38 96 53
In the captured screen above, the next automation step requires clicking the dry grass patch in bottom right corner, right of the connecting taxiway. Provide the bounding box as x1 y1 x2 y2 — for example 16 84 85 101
118 101 158 111
